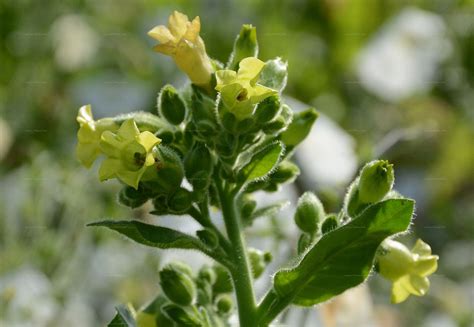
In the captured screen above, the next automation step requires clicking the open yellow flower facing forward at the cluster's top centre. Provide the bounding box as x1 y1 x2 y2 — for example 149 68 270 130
216 57 277 118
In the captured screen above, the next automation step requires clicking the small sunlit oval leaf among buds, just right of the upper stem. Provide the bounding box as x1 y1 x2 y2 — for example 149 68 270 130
239 142 284 183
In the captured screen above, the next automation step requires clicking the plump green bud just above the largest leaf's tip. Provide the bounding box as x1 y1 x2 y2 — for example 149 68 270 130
359 160 395 203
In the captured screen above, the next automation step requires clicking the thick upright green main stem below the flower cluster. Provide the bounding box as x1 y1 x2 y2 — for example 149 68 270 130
215 178 257 327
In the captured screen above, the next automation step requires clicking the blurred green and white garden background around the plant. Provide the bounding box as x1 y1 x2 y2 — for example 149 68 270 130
0 0 474 326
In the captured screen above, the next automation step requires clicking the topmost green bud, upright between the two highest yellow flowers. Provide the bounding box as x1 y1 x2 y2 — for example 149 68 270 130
227 24 258 70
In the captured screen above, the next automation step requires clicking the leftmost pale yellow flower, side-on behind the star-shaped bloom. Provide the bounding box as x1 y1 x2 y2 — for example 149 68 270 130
76 105 119 168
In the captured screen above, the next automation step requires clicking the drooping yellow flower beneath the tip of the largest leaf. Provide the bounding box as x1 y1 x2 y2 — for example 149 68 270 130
377 239 438 303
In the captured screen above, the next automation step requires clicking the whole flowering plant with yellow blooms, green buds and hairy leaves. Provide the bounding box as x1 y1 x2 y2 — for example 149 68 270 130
77 12 438 327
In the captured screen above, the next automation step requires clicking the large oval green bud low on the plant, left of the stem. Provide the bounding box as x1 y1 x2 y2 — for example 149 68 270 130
160 264 196 305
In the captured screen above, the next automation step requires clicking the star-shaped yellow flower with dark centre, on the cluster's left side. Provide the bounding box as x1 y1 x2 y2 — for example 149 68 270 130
99 119 161 189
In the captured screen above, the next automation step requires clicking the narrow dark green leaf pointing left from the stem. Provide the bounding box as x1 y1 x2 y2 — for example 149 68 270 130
87 220 206 250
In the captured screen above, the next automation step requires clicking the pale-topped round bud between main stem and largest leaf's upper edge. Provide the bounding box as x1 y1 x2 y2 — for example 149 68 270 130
295 192 325 234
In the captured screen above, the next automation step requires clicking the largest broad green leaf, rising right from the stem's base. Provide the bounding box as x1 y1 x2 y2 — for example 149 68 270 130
273 199 414 306
